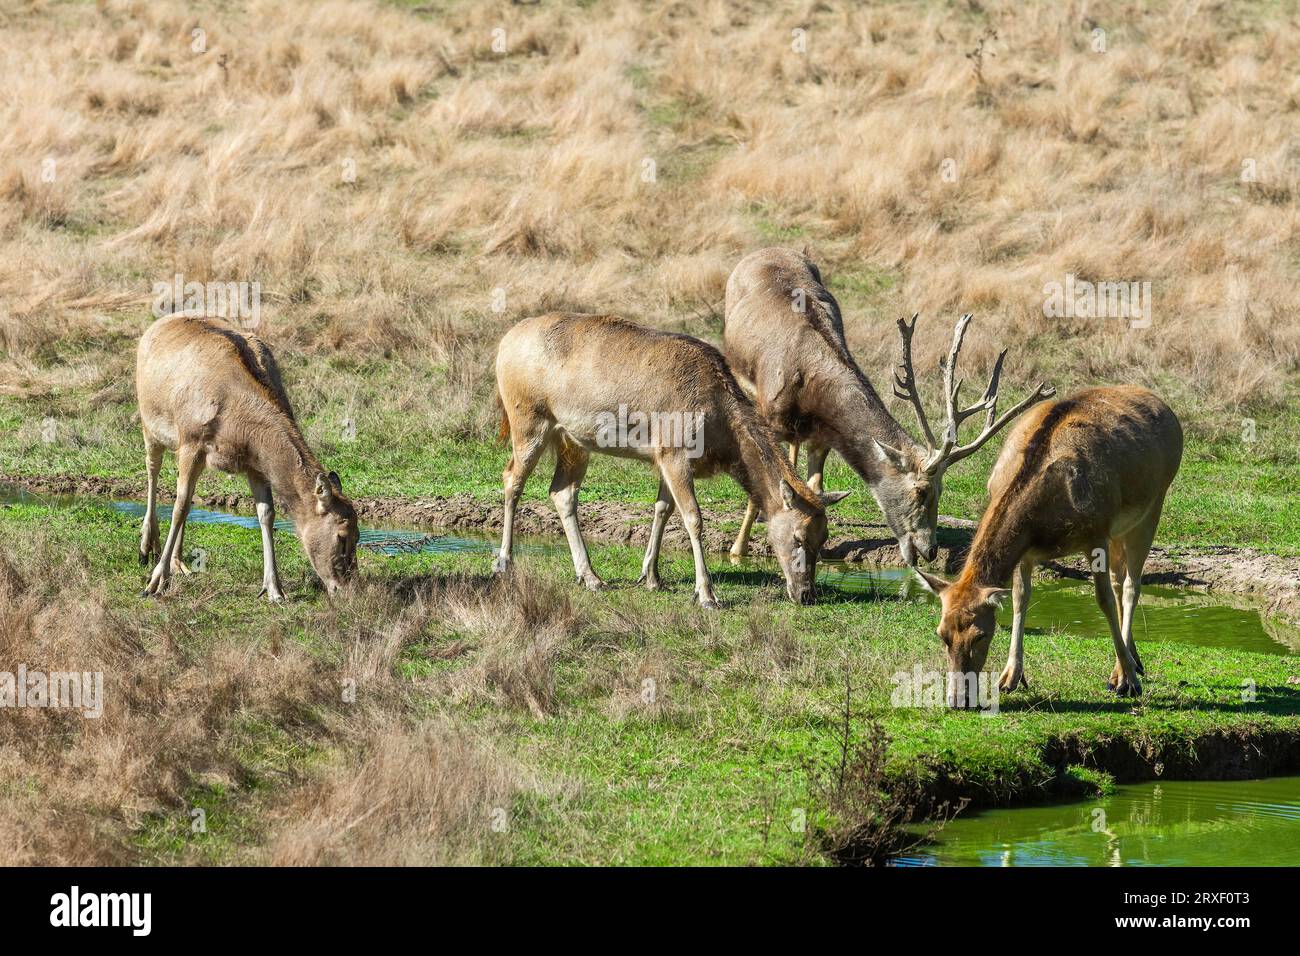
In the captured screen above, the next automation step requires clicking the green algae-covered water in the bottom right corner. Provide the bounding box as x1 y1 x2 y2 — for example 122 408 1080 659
893 777 1300 866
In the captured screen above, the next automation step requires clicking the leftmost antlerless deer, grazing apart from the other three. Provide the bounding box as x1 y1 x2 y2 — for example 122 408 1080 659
135 315 358 601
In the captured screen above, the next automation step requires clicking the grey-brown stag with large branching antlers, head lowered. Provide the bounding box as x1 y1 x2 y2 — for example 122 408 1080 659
723 248 1056 564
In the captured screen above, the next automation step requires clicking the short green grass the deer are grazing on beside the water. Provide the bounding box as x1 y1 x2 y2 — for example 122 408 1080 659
0 503 1300 864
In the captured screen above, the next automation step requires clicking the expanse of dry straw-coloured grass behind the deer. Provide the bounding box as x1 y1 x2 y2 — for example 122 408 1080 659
0 0 1300 434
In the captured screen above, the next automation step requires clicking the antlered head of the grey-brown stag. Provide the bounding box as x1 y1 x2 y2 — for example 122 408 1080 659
872 313 1056 564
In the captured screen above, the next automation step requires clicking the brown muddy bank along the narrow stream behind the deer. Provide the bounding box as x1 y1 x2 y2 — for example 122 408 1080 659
0 475 1300 622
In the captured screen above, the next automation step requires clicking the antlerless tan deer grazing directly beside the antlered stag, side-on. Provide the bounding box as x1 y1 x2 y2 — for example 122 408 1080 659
493 312 846 610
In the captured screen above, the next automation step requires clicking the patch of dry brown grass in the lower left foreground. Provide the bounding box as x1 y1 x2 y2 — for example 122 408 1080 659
0 538 558 865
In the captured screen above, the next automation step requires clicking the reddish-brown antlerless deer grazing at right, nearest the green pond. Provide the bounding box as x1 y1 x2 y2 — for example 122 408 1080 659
918 386 1183 706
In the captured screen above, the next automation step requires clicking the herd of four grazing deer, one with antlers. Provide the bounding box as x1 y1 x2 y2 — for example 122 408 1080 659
137 248 1183 705
